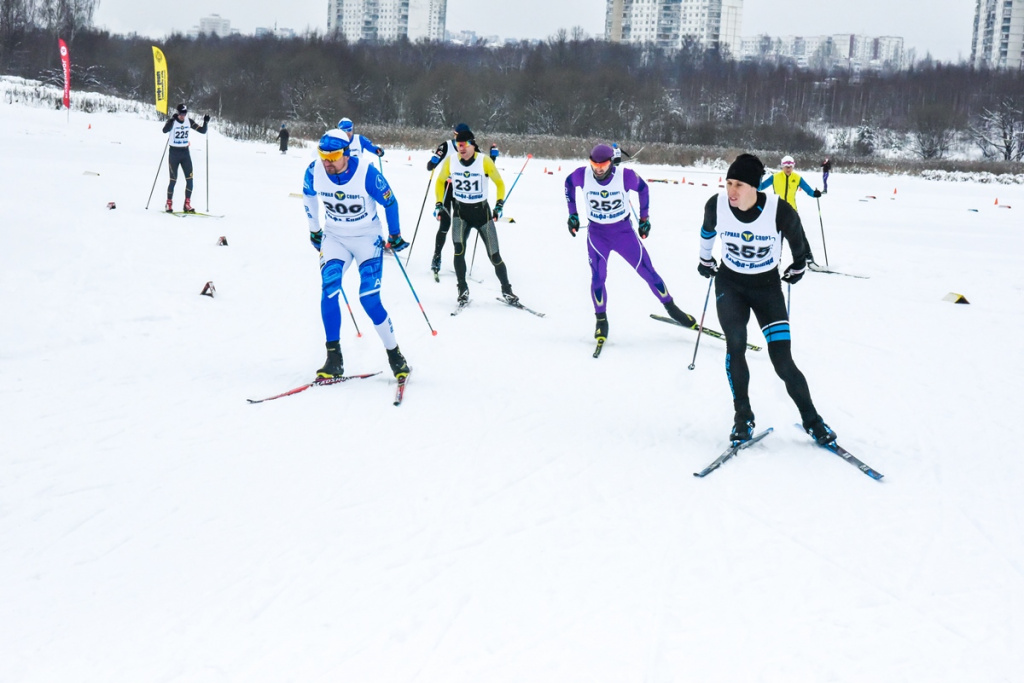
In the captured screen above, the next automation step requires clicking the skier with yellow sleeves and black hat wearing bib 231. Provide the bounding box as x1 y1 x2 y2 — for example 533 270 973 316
434 126 519 306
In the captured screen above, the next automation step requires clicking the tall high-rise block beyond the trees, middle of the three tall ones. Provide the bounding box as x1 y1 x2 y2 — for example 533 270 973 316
604 0 743 50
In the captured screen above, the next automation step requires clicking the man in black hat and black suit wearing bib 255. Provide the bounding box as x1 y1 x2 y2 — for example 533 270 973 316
697 154 836 445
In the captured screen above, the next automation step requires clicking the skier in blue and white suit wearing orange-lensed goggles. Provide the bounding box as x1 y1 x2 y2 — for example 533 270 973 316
302 130 410 378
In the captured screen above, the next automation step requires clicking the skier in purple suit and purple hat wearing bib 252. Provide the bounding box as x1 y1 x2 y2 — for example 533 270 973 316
565 144 697 341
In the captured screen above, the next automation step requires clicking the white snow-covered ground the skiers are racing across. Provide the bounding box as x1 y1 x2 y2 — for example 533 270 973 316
0 97 1024 683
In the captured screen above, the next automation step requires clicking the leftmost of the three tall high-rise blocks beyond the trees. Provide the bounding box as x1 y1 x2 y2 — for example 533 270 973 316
327 0 447 42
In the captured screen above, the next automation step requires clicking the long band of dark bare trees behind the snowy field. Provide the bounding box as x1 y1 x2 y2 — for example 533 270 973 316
6 15 1024 162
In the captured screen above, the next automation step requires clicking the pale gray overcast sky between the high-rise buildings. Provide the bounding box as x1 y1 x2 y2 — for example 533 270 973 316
95 0 975 61
